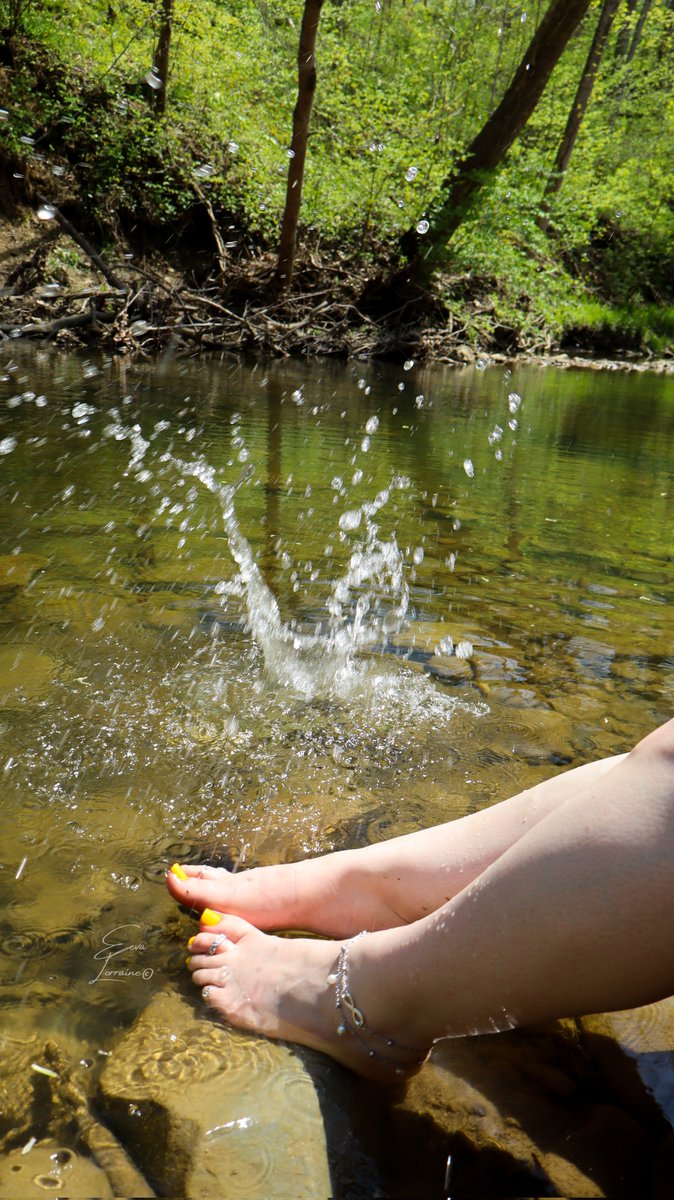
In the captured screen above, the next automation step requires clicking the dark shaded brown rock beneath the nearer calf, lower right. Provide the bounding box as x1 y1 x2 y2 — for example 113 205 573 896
385 1021 661 1200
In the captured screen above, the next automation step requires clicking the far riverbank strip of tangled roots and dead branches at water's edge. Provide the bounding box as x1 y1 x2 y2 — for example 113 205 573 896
0 211 674 373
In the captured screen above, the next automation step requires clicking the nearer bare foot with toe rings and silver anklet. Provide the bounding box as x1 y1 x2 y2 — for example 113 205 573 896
188 910 427 1084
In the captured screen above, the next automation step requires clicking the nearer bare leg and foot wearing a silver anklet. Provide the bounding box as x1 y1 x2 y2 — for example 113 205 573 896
182 721 674 1079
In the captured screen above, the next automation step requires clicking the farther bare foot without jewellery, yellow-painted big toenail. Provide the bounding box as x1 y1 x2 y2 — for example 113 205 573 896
167 853 401 937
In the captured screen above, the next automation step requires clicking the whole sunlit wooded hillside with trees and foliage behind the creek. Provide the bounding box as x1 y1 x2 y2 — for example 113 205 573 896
0 0 674 355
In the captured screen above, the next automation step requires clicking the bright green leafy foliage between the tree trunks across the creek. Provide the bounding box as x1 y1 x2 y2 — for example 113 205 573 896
0 0 674 343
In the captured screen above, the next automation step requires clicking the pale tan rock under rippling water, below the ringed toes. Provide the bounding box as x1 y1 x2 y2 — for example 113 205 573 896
100 994 333 1200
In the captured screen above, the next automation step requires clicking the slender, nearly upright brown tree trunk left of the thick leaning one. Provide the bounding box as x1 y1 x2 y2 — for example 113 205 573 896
275 0 323 292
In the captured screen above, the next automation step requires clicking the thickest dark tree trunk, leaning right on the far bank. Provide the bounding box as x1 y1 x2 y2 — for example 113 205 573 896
403 0 590 282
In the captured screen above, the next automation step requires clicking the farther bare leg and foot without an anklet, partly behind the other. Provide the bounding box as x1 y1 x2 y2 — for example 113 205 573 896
167 755 625 937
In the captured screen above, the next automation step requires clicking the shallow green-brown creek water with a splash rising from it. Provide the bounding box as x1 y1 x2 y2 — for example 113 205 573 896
0 347 674 1190
